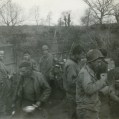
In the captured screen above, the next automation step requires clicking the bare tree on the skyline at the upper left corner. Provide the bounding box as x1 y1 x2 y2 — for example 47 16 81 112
0 1 24 26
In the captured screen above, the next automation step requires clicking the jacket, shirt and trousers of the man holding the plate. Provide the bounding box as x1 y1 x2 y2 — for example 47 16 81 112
15 71 51 119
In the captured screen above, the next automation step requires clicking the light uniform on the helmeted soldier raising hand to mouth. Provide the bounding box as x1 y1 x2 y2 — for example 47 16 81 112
76 65 106 119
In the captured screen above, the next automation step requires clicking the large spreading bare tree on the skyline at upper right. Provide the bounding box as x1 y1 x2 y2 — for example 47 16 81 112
83 0 113 25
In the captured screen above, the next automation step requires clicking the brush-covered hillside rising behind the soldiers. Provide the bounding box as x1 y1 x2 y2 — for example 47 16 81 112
0 24 119 64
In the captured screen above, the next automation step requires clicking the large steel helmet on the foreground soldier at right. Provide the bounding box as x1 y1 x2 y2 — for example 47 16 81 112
87 49 104 62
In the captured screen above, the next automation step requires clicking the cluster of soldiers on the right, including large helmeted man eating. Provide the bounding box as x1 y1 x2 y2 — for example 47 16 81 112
64 46 119 119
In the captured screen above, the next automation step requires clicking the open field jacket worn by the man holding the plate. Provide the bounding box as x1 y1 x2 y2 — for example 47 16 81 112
14 71 51 102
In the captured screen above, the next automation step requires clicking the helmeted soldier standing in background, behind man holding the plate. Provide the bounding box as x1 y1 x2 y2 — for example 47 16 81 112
39 45 53 84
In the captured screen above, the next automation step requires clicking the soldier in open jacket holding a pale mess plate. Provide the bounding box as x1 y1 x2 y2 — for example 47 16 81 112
14 62 51 119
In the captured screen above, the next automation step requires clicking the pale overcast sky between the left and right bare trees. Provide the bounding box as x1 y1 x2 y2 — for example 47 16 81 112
12 0 87 24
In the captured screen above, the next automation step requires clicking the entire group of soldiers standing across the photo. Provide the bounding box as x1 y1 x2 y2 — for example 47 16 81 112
0 45 119 119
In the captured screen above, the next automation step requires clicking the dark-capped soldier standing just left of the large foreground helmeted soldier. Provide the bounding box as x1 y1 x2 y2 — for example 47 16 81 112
63 45 82 119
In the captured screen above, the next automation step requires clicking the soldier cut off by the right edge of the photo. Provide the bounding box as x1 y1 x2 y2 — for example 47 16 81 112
108 67 119 119
